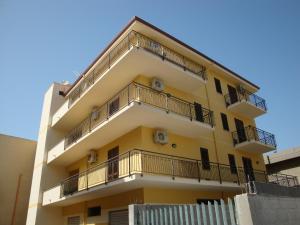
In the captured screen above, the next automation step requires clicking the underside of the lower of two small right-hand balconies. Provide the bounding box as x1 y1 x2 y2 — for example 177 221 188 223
235 140 276 154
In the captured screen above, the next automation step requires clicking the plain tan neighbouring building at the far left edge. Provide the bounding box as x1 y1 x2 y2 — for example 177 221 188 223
0 134 36 225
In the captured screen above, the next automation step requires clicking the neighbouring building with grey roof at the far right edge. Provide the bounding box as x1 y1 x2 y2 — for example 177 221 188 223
264 147 300 184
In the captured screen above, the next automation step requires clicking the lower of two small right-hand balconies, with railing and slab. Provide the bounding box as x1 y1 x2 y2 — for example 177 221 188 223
232 126 276 153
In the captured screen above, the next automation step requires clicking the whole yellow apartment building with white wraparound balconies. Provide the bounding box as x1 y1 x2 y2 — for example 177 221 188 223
27 17 276 225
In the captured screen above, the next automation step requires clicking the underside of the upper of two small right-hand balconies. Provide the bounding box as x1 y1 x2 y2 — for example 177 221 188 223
228 100 266 119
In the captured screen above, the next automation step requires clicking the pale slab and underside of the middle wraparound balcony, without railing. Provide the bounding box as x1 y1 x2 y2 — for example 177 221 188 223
48 102 214 165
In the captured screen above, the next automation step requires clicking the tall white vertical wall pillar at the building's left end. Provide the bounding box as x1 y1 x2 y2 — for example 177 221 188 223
26 84 65 225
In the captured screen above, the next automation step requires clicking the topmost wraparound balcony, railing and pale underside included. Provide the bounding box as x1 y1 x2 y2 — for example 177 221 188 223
52 31 206 131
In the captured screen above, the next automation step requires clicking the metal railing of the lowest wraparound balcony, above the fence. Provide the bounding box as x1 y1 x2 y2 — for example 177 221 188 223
61 149 268 197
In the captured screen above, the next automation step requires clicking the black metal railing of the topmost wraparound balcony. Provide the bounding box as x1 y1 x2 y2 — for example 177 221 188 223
69 31 206 107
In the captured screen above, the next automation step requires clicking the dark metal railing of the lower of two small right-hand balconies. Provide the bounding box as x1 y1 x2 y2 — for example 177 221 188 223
232 126 276 148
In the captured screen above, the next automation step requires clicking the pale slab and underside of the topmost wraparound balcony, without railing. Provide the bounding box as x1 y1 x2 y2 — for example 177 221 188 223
52 47 205 131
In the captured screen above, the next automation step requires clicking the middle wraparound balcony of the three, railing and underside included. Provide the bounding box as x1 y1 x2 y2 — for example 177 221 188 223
48 83 214 165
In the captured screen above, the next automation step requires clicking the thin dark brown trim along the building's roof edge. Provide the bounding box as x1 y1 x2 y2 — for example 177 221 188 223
65 16 259 95
